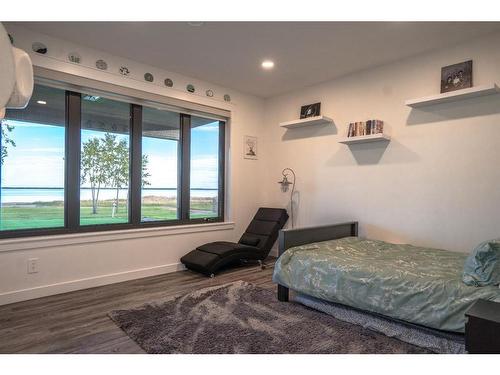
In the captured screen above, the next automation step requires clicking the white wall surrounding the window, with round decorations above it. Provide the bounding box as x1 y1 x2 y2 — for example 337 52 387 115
0 26 264 304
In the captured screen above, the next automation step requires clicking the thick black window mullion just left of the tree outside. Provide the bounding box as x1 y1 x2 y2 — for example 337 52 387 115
64 91 82 231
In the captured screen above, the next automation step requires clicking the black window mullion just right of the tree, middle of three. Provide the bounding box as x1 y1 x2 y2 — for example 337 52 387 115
129 104 142 225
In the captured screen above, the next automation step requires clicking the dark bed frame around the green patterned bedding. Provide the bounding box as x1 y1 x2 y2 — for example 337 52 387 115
278 221 464 339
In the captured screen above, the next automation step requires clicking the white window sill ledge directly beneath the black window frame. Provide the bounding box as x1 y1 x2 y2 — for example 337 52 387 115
0 221 234 253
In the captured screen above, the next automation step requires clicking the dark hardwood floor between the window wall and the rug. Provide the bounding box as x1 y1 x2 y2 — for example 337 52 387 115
0 259 275 353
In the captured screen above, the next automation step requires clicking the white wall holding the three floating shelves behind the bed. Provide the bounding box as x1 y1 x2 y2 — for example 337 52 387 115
263 29 500 252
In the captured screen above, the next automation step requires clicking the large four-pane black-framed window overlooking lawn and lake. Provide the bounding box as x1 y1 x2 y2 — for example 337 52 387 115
0 84 225 238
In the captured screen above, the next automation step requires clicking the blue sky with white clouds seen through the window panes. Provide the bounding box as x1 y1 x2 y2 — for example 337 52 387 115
2 120 218 188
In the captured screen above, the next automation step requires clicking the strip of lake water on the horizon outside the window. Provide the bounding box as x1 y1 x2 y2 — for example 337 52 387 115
0 188 217 203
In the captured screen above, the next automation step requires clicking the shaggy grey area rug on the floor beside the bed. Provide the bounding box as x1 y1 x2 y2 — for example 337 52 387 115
109 281 428 354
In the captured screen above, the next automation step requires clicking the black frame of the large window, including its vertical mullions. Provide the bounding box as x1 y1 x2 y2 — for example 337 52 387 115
0 81 228 239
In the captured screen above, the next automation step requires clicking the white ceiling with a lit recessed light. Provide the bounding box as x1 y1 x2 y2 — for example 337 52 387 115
9 22 500 97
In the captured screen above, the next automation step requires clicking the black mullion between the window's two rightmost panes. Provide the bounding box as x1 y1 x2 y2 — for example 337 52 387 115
179 114 191 221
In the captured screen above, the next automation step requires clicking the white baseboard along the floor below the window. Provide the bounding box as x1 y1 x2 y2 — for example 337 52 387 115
0 263 186 305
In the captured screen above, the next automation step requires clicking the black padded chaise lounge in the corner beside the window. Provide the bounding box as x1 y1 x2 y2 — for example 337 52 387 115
181 207 288 277
